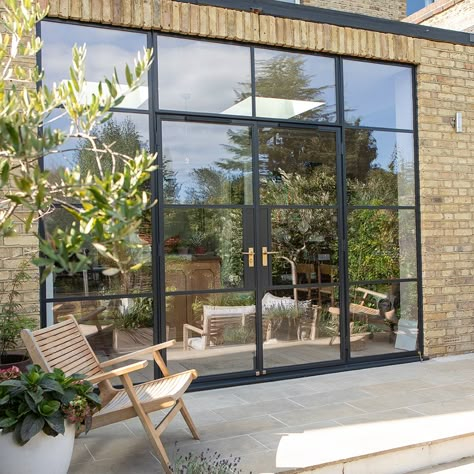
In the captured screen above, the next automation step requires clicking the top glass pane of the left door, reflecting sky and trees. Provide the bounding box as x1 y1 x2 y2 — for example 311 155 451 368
162 122 252 204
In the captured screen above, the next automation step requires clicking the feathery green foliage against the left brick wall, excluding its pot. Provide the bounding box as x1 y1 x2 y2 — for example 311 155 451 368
0 261 36 363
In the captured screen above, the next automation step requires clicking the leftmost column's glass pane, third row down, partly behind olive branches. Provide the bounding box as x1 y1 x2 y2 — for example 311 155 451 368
43 208 152 298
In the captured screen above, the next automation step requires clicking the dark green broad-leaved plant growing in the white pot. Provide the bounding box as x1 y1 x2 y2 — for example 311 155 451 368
0 365 101 445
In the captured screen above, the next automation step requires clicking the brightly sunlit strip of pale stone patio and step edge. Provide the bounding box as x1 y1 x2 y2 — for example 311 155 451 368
276 407 474 474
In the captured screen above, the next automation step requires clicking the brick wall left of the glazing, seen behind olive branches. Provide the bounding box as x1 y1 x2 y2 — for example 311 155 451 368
0 7 39 328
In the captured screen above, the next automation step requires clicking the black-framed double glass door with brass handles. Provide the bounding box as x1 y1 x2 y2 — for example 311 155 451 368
161 121 342 376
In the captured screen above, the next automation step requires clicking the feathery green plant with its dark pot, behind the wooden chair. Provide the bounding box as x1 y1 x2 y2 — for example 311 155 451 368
0 261 36 370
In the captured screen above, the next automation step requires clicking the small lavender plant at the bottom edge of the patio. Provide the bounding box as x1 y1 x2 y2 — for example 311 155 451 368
172 449 242 474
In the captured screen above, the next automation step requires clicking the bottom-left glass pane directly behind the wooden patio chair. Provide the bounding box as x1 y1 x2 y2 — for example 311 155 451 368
46 298 155 384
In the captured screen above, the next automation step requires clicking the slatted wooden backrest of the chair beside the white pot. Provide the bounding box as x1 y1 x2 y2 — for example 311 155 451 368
21 316 103 377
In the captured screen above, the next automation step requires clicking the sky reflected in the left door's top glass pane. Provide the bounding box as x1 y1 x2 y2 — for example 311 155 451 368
162 122 252 204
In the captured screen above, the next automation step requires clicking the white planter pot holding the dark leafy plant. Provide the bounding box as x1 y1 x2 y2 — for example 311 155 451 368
0 423 76 474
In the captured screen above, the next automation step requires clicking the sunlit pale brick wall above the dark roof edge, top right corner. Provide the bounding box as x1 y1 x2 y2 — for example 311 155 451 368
405 0 474 32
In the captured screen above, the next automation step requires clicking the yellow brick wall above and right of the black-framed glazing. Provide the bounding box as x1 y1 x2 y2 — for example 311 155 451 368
35 0 474 356
